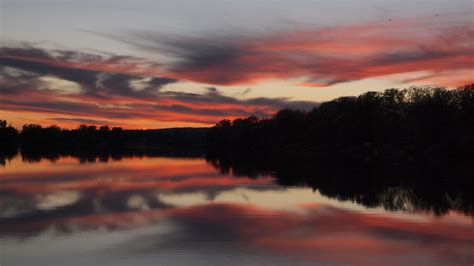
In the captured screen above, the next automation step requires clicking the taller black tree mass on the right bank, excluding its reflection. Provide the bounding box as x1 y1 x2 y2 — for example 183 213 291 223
207 84 474 164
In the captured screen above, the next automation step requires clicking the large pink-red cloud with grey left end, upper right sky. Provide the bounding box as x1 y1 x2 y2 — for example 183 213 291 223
109 14 474 86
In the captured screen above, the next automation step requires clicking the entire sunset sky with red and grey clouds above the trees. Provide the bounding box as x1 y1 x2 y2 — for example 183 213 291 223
0 0 474 128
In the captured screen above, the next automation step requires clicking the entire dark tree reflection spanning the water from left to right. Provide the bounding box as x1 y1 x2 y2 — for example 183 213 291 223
0 149 474 215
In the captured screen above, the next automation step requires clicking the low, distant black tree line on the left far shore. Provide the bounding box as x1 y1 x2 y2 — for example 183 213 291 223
0 120 207 151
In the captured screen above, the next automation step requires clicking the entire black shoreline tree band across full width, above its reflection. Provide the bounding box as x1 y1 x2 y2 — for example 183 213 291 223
0 85 474 160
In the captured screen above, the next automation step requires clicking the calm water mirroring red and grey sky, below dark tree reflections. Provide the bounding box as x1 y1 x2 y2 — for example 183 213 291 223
0 153 474 266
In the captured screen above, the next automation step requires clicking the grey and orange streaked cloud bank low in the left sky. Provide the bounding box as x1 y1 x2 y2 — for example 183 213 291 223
0 47 316 127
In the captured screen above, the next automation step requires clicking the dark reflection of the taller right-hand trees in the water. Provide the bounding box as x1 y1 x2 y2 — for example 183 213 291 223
206 155 474 215
